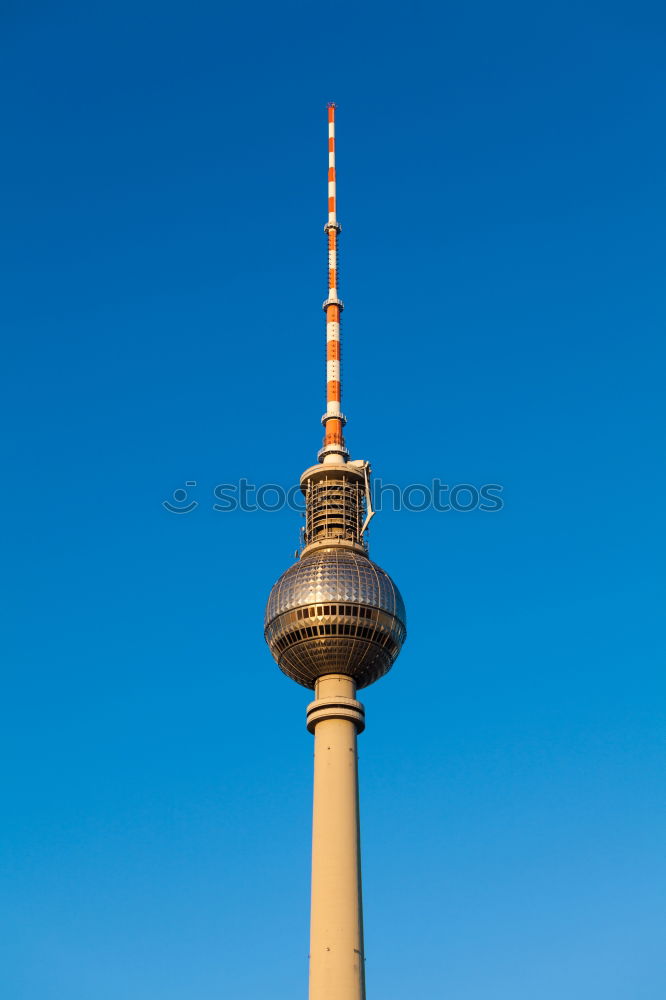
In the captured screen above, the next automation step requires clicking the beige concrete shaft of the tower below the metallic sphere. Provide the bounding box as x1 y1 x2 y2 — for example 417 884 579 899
307 674 365 1000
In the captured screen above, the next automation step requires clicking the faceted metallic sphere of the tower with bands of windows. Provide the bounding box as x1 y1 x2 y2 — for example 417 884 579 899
264 545 407 688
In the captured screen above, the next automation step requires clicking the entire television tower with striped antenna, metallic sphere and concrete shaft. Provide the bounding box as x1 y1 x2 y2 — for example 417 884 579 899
264 104 406 1000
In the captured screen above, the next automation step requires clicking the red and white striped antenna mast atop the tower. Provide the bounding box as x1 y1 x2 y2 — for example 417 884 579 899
319 103 349 464
